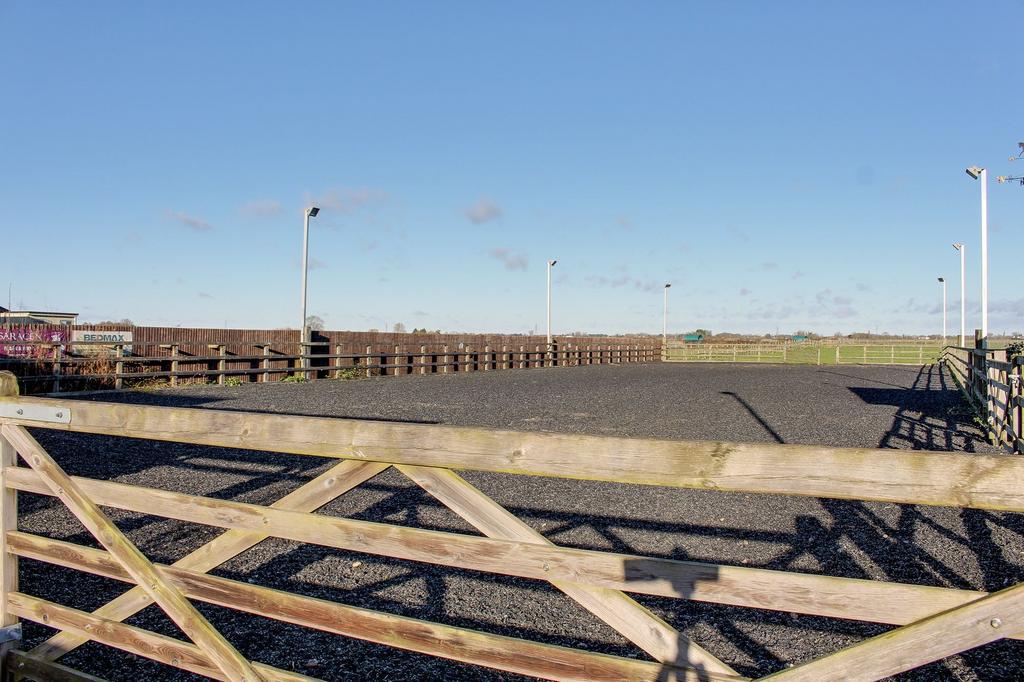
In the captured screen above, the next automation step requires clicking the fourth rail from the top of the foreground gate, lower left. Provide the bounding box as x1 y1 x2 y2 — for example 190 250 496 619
7 592 316 682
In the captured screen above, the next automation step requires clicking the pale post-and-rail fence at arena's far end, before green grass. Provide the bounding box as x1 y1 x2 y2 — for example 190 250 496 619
665 341 941 365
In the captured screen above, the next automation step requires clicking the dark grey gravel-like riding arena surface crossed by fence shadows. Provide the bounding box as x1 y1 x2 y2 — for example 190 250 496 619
12 365 1024 680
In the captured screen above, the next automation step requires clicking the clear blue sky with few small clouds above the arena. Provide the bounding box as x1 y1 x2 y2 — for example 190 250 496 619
0 2 1024 333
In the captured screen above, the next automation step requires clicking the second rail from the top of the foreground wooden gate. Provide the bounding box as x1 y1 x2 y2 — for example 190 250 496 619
7 467 1003 625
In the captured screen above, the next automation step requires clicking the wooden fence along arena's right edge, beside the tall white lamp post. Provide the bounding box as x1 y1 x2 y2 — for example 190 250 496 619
942 346 1024 454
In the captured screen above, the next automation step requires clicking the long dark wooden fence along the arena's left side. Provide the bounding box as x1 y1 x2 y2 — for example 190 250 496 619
0 341 660 393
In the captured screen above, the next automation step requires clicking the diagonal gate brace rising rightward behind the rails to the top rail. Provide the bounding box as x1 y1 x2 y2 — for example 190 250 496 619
33 461 390 659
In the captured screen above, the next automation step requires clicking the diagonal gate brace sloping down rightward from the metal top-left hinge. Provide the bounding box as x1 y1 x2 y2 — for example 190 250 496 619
2 424 260 682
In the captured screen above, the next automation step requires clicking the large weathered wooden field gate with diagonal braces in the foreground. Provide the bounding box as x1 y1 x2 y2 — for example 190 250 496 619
0 373 1024 682
